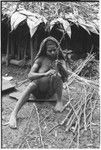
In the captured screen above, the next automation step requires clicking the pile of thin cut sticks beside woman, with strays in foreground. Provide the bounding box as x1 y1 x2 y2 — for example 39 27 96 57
18 54 99 148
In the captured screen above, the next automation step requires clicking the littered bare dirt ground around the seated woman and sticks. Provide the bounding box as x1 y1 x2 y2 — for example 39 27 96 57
1 64 100 149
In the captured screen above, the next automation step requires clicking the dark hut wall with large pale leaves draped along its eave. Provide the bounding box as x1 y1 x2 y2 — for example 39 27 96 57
1 3 99 65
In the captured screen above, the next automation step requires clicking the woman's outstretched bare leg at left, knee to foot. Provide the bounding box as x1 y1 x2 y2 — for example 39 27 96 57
9 82 37 128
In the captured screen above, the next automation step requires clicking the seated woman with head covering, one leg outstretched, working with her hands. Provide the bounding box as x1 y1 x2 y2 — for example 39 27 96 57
9 37 68 128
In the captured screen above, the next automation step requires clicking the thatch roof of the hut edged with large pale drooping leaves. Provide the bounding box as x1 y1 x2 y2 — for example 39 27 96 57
2 2 99 38
